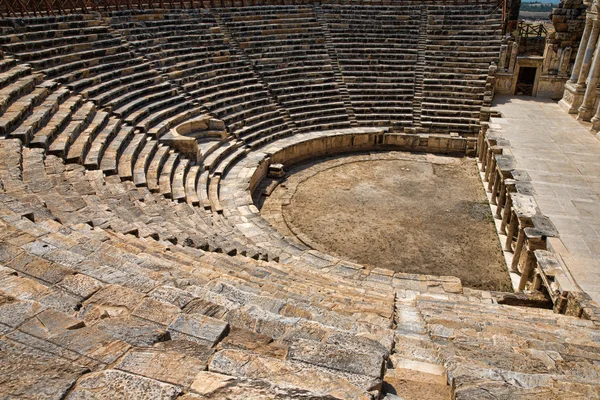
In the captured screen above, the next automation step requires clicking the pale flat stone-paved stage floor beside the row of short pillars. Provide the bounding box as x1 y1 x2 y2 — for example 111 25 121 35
491 96 600 302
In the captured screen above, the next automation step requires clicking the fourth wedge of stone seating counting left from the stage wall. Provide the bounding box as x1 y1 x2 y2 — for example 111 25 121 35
110 10 298 148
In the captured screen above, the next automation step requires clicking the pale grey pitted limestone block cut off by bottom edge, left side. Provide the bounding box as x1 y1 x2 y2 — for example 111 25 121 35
67 369 181 400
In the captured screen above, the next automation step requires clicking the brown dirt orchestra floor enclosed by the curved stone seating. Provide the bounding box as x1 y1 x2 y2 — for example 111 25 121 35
261 152 511 291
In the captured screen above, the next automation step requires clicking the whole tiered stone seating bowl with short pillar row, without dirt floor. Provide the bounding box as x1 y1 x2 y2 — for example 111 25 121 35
0 0 600 400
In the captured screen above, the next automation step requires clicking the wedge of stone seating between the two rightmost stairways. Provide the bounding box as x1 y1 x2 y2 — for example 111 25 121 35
322 5 422 128
